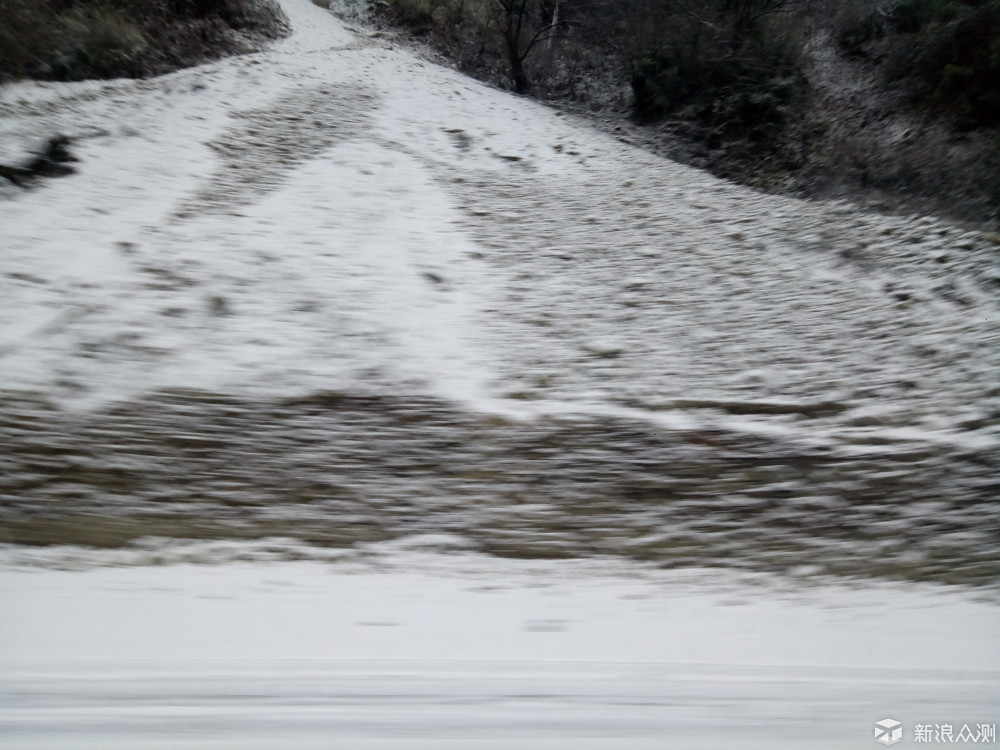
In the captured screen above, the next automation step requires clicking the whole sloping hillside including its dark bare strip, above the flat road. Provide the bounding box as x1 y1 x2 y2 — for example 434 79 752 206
0 0 1000 585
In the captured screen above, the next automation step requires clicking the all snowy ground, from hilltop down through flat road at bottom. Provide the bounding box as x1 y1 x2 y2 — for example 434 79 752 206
0 0 1000 750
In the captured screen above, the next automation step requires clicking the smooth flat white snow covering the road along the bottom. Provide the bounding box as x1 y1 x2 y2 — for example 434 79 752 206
0 540 1000 750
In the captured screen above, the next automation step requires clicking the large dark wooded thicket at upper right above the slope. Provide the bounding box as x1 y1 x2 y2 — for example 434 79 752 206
373 0 1000 225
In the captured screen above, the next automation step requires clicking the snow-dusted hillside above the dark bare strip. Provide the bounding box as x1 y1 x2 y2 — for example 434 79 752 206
0 0 1000 446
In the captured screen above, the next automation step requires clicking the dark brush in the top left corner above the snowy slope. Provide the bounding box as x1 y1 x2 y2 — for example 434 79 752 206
0 0 287 81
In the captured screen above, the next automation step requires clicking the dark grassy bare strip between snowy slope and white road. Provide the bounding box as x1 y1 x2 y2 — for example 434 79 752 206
0 391 1000 587
